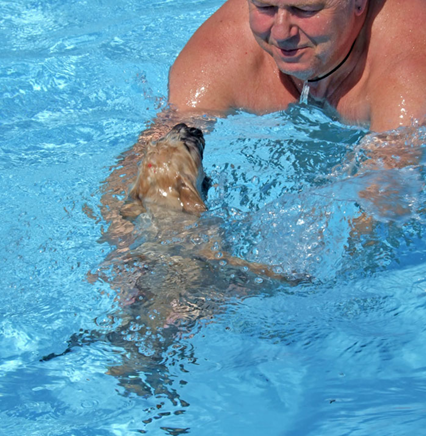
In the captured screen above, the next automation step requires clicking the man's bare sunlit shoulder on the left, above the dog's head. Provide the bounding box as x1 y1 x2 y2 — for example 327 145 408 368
169 0 265 110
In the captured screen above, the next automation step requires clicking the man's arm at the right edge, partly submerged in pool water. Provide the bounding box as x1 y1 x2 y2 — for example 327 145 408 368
358 30 426 219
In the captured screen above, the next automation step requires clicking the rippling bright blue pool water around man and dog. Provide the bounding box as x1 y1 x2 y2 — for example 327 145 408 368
0 0 426 436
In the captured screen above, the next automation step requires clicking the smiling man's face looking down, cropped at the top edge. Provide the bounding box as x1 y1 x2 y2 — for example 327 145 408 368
248 0 362 80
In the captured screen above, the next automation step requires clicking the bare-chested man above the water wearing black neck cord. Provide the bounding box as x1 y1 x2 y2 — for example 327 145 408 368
169 0 426 132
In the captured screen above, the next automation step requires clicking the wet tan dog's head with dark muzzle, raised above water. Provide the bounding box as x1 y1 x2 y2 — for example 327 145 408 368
121 123 206 218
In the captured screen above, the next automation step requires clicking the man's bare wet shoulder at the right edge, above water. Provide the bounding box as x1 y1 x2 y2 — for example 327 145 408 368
367 0 426 130
